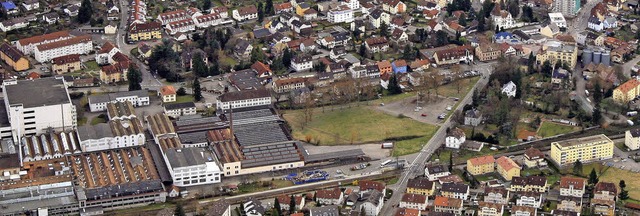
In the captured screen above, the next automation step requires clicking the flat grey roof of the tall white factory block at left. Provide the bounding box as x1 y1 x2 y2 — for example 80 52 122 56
5 77 71 108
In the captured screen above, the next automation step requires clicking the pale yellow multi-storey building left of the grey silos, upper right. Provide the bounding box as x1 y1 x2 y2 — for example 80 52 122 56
536 42 578 68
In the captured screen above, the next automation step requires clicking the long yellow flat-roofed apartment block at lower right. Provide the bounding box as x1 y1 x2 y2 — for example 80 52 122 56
550 134 614 166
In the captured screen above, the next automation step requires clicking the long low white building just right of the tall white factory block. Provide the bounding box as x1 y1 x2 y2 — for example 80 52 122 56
89 90 149 112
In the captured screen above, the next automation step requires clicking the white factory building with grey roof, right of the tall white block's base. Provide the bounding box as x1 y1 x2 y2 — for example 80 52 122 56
78 118 146 152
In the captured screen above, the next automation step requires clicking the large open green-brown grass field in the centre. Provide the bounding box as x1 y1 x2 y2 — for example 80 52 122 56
284 105 437 155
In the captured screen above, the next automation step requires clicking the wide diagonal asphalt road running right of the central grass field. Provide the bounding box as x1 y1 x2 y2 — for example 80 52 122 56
379 63 492 215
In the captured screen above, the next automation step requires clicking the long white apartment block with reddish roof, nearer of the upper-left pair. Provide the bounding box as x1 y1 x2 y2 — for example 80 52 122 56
34 35 93 63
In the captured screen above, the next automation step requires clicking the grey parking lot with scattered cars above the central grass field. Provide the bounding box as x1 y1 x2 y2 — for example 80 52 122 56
378 93 457 125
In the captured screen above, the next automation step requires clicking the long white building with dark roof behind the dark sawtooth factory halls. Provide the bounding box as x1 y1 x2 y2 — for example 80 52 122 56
216 89 271 111
